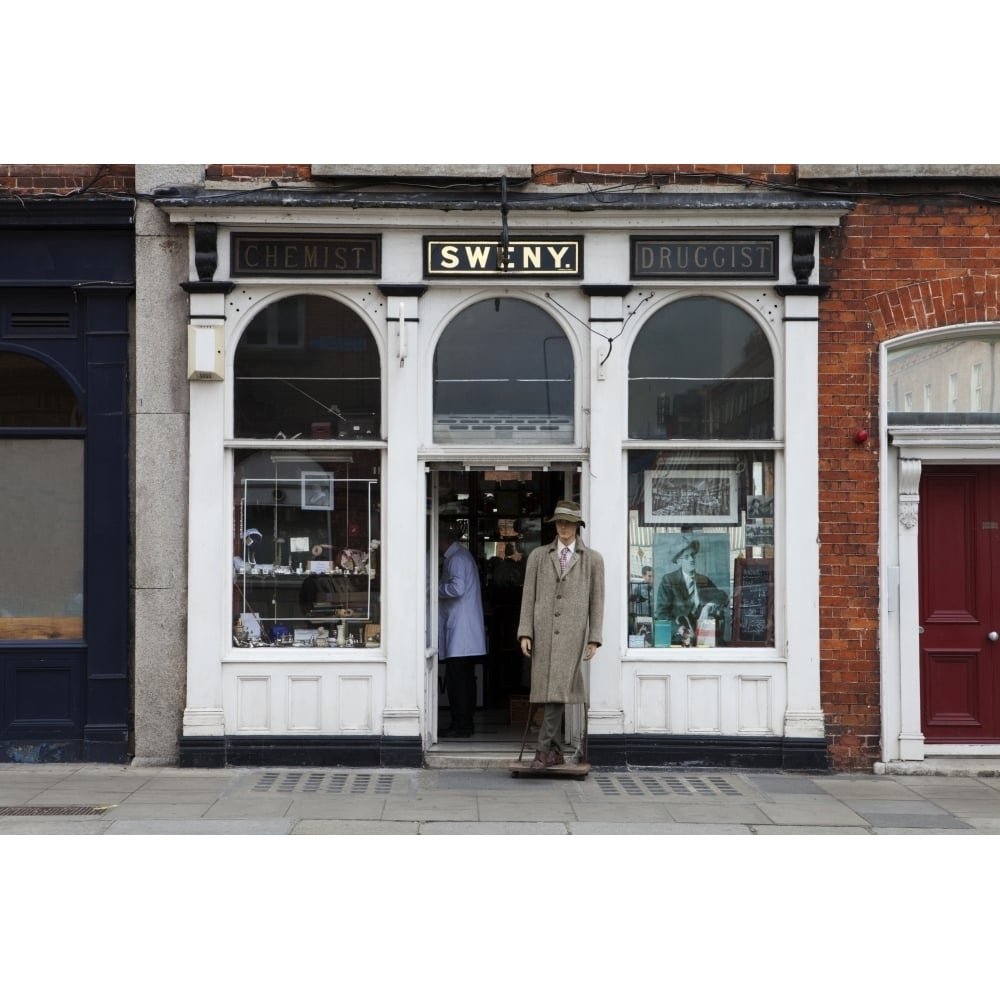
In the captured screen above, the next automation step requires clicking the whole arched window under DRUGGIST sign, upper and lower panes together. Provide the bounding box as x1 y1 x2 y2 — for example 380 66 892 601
626 296 775 655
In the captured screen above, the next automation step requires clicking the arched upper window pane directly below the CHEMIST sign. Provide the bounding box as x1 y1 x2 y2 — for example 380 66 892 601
234 295 381 439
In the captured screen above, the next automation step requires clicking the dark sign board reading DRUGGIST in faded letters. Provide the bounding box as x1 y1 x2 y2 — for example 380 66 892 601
631 236 778 280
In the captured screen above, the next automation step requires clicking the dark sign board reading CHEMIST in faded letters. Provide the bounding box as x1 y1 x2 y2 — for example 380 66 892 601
229 233 382 278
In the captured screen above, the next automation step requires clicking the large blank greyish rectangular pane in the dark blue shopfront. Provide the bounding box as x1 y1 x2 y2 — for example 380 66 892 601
0 439 83 639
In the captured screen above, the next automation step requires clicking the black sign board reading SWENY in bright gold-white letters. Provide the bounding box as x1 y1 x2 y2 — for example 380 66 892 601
424 236 583 279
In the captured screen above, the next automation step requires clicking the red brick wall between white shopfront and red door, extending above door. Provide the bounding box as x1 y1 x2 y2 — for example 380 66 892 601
820 197 1000 771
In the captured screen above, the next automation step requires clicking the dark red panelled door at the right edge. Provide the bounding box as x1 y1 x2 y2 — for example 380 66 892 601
919 465 1000 743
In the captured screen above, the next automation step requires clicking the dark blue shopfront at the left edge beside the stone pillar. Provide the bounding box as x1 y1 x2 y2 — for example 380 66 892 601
0 198 135 762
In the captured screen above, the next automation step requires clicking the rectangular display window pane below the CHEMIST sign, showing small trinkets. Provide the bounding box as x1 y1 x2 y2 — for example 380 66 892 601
233 450 381 647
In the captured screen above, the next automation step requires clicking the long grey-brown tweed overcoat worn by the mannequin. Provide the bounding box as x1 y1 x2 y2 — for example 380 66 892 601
517 535 604 705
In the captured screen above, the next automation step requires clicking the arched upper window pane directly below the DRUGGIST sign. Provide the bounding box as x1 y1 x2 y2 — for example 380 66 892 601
629 297 774 440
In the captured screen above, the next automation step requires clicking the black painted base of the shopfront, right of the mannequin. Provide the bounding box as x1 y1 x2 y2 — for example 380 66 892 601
587 733 831 772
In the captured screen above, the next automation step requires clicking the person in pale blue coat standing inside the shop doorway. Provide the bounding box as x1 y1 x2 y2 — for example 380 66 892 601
438 523 486 738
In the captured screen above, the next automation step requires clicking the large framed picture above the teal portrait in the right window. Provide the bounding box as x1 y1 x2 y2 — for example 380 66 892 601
643 468 740 525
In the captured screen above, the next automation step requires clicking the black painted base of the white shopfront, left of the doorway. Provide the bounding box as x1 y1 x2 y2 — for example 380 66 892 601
178 736 424 767
